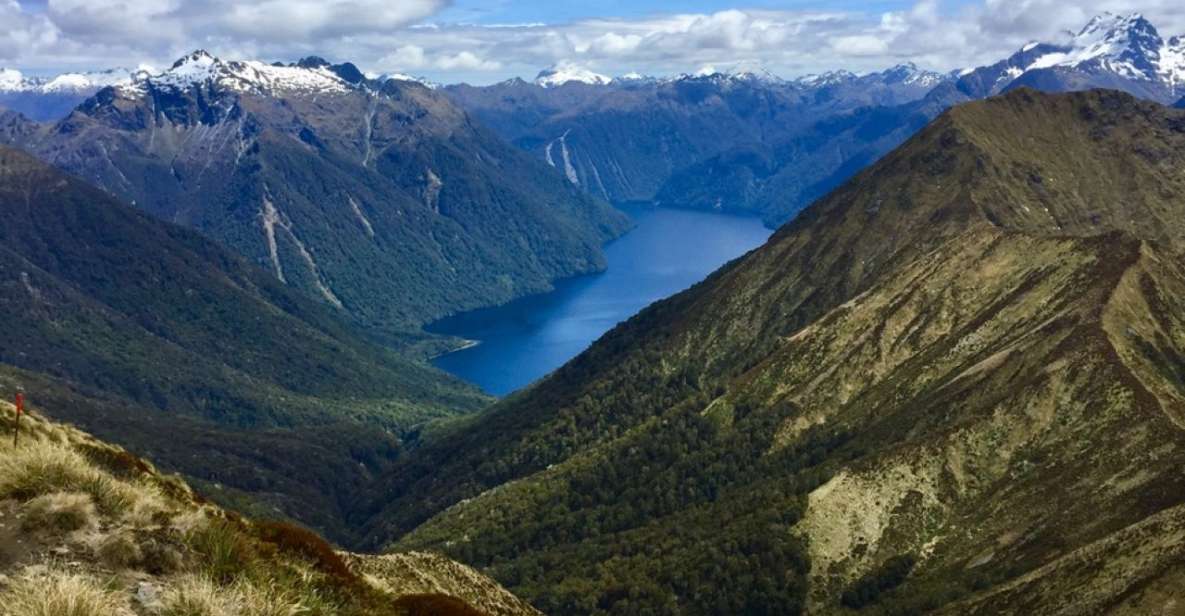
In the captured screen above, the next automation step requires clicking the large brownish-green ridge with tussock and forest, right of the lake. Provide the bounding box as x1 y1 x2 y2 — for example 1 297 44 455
357 89 1185 614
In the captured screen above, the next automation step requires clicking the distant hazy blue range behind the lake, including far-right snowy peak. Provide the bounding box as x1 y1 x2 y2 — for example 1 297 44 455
447 14 1185 225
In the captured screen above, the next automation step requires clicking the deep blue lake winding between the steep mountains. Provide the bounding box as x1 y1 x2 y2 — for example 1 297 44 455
428 206 770 396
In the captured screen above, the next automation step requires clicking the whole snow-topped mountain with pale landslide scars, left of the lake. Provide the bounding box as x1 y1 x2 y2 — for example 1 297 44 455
6 52 626 341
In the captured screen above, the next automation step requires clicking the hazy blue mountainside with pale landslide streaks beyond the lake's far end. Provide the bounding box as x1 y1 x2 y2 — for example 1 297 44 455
446 76 798 206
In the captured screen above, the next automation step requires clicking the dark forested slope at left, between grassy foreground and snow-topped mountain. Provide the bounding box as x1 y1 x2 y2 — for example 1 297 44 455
0 148 486 547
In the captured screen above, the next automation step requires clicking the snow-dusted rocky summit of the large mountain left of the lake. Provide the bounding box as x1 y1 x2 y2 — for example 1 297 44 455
127 50 351 94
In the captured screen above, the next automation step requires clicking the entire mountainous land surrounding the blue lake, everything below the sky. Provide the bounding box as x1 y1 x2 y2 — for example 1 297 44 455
0 10 1185 616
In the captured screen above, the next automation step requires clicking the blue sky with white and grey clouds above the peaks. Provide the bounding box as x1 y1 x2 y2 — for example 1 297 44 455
0 0 1185 84
